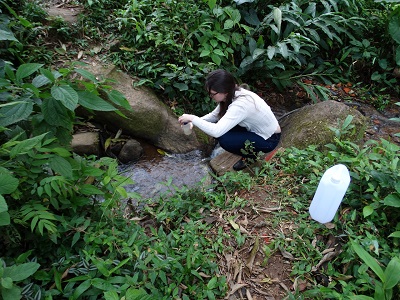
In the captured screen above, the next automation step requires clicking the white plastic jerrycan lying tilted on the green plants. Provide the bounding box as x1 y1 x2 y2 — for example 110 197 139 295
309 164 350 224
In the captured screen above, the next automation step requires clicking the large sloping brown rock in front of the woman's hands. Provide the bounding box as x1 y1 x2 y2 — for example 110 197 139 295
78 63 201 153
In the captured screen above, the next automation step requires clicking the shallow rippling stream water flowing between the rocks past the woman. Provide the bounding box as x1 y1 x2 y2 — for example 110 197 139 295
120 98 400 199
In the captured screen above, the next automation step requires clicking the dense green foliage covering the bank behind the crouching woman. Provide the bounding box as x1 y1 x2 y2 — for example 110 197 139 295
76 0 400 112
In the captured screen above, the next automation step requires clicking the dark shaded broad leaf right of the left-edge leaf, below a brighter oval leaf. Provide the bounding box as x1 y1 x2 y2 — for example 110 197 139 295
42 98 74 129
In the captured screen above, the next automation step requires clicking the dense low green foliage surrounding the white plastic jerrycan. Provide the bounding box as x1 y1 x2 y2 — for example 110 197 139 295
266 118 400 299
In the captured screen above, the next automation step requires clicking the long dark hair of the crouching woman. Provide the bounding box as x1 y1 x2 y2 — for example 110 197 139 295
205 69 238 118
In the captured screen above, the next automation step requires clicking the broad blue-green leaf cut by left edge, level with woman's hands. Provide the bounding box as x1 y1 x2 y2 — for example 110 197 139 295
0 97 33 127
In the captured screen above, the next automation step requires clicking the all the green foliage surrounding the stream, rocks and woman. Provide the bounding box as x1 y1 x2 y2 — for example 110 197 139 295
0 0 400 300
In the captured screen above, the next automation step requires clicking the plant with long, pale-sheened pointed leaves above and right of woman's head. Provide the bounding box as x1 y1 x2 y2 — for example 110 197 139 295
240 1 362 92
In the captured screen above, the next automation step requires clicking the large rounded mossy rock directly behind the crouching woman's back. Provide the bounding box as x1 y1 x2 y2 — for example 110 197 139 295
280 100 367 150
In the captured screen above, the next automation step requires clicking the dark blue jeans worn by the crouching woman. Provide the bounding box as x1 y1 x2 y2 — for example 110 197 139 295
217 125 281 159
